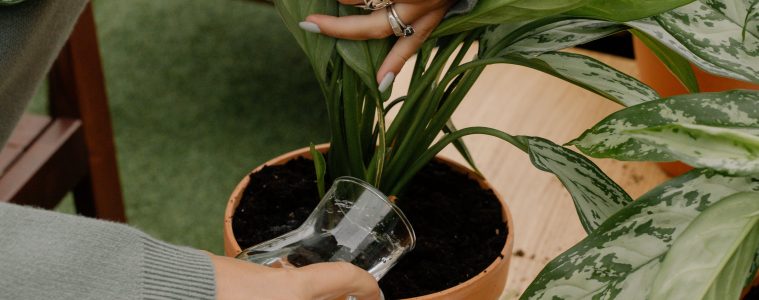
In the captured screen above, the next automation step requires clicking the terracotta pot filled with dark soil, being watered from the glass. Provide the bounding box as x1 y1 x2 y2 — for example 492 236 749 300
224 144 514 300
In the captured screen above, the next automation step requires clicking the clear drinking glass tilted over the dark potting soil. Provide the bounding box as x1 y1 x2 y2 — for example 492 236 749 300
237 177 416 280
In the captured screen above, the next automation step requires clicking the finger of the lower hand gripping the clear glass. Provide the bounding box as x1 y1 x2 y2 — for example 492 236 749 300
295 262 380 300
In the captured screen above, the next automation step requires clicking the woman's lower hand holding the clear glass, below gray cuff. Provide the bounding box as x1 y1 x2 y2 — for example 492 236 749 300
209 254 381 300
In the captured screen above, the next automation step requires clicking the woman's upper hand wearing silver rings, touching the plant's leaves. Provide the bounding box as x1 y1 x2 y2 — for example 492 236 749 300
300 0 456 91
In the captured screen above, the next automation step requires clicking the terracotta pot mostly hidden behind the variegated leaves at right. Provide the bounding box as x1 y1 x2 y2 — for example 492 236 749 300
633 38 759 177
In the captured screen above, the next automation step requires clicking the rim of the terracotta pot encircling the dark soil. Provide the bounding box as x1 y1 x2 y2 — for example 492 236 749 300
224 144 514 300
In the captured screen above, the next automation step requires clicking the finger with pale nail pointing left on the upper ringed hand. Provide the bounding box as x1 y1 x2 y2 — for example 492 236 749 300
308 4 429 40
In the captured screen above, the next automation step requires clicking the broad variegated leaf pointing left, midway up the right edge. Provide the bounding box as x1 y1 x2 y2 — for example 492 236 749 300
570 90 759 174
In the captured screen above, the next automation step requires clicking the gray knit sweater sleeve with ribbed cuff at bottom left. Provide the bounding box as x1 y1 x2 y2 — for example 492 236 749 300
0 203 215 299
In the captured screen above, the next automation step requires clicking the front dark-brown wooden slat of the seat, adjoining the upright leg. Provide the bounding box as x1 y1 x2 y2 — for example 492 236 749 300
0 118 87 208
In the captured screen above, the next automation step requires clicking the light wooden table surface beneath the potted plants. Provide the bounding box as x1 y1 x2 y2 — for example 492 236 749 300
393 50 667 299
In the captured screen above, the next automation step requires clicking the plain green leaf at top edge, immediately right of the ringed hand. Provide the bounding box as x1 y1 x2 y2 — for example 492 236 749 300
432 0 589 37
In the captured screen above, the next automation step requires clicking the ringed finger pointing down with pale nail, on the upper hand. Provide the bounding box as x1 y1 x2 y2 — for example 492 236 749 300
377 9 446 85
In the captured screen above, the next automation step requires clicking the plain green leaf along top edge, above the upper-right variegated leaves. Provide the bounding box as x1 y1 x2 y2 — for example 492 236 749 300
567 0 693 22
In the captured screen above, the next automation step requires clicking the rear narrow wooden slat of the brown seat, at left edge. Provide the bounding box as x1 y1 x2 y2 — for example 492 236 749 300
0 114 50 176
